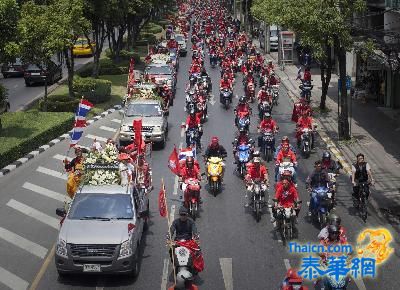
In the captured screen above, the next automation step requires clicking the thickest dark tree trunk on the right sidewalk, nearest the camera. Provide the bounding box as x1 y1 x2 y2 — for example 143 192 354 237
339 46 350 140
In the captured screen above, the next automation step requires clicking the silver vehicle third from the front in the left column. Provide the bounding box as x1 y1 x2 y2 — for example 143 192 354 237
144 63 176 95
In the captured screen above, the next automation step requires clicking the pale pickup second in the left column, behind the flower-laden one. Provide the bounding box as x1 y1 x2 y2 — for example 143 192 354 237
119 99 168 147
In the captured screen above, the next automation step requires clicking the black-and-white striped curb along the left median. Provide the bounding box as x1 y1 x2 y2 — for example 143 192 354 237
0 105 122 177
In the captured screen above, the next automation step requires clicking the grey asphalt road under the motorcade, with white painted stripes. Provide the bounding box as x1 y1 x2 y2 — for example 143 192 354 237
0 38 400 290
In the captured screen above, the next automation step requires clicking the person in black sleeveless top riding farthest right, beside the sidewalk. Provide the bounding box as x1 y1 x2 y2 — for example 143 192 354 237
351 153 375 202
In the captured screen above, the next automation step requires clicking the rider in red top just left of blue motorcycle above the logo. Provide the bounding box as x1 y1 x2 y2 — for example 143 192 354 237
271 178 300 232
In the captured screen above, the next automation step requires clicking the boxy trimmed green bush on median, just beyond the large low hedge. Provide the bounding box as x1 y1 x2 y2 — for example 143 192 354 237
73 77 112 104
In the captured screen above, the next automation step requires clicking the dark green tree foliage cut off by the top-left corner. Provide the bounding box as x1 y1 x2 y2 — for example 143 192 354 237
0 0 19 61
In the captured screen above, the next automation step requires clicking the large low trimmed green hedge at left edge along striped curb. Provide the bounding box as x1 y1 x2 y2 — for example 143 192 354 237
0 111 74 168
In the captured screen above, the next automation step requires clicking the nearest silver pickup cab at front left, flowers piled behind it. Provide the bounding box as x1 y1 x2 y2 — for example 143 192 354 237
55 185 149 277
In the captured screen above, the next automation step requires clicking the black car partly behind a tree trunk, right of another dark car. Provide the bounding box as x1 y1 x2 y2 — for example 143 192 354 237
24 61 62 87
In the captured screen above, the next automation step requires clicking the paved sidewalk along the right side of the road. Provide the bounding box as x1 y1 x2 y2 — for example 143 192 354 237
269 50 400 212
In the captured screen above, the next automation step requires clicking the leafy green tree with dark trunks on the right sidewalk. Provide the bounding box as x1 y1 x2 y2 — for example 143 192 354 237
252 0 365 139
